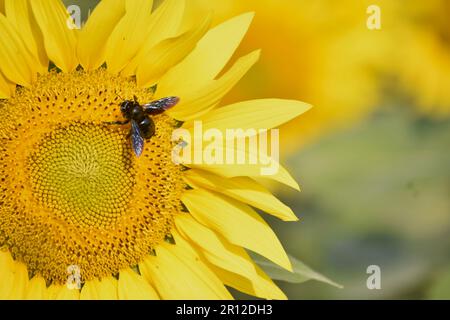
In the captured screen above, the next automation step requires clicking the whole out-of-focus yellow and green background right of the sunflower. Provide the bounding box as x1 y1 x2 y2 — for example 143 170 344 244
66 0 450 299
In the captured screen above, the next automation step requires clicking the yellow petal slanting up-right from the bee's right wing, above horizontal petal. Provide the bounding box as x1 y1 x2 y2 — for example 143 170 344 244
164 50 260 121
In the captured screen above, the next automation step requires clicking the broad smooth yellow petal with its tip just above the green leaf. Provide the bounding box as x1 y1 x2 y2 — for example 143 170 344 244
181 189 292 270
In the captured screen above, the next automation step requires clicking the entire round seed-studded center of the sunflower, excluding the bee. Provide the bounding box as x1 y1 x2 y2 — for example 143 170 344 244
0 70 185 284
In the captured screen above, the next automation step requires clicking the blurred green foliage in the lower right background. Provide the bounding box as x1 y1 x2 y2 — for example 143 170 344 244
273 101 450 299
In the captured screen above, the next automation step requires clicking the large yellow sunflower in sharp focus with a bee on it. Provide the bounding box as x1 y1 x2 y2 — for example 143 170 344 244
0 0 309 299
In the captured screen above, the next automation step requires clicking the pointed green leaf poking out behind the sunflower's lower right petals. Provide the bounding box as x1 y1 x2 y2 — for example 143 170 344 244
250 253 343 289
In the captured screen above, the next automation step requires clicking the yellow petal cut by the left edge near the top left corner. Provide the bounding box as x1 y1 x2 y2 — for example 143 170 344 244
0 15 37 87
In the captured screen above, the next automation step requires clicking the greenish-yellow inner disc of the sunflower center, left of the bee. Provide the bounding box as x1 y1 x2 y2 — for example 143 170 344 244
29 123 134 227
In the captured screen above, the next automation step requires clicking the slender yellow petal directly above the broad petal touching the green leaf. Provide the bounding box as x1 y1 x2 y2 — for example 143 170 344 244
184 169 298 221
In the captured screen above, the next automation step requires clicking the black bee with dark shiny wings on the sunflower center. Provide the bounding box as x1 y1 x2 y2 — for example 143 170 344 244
112 96 180 157
